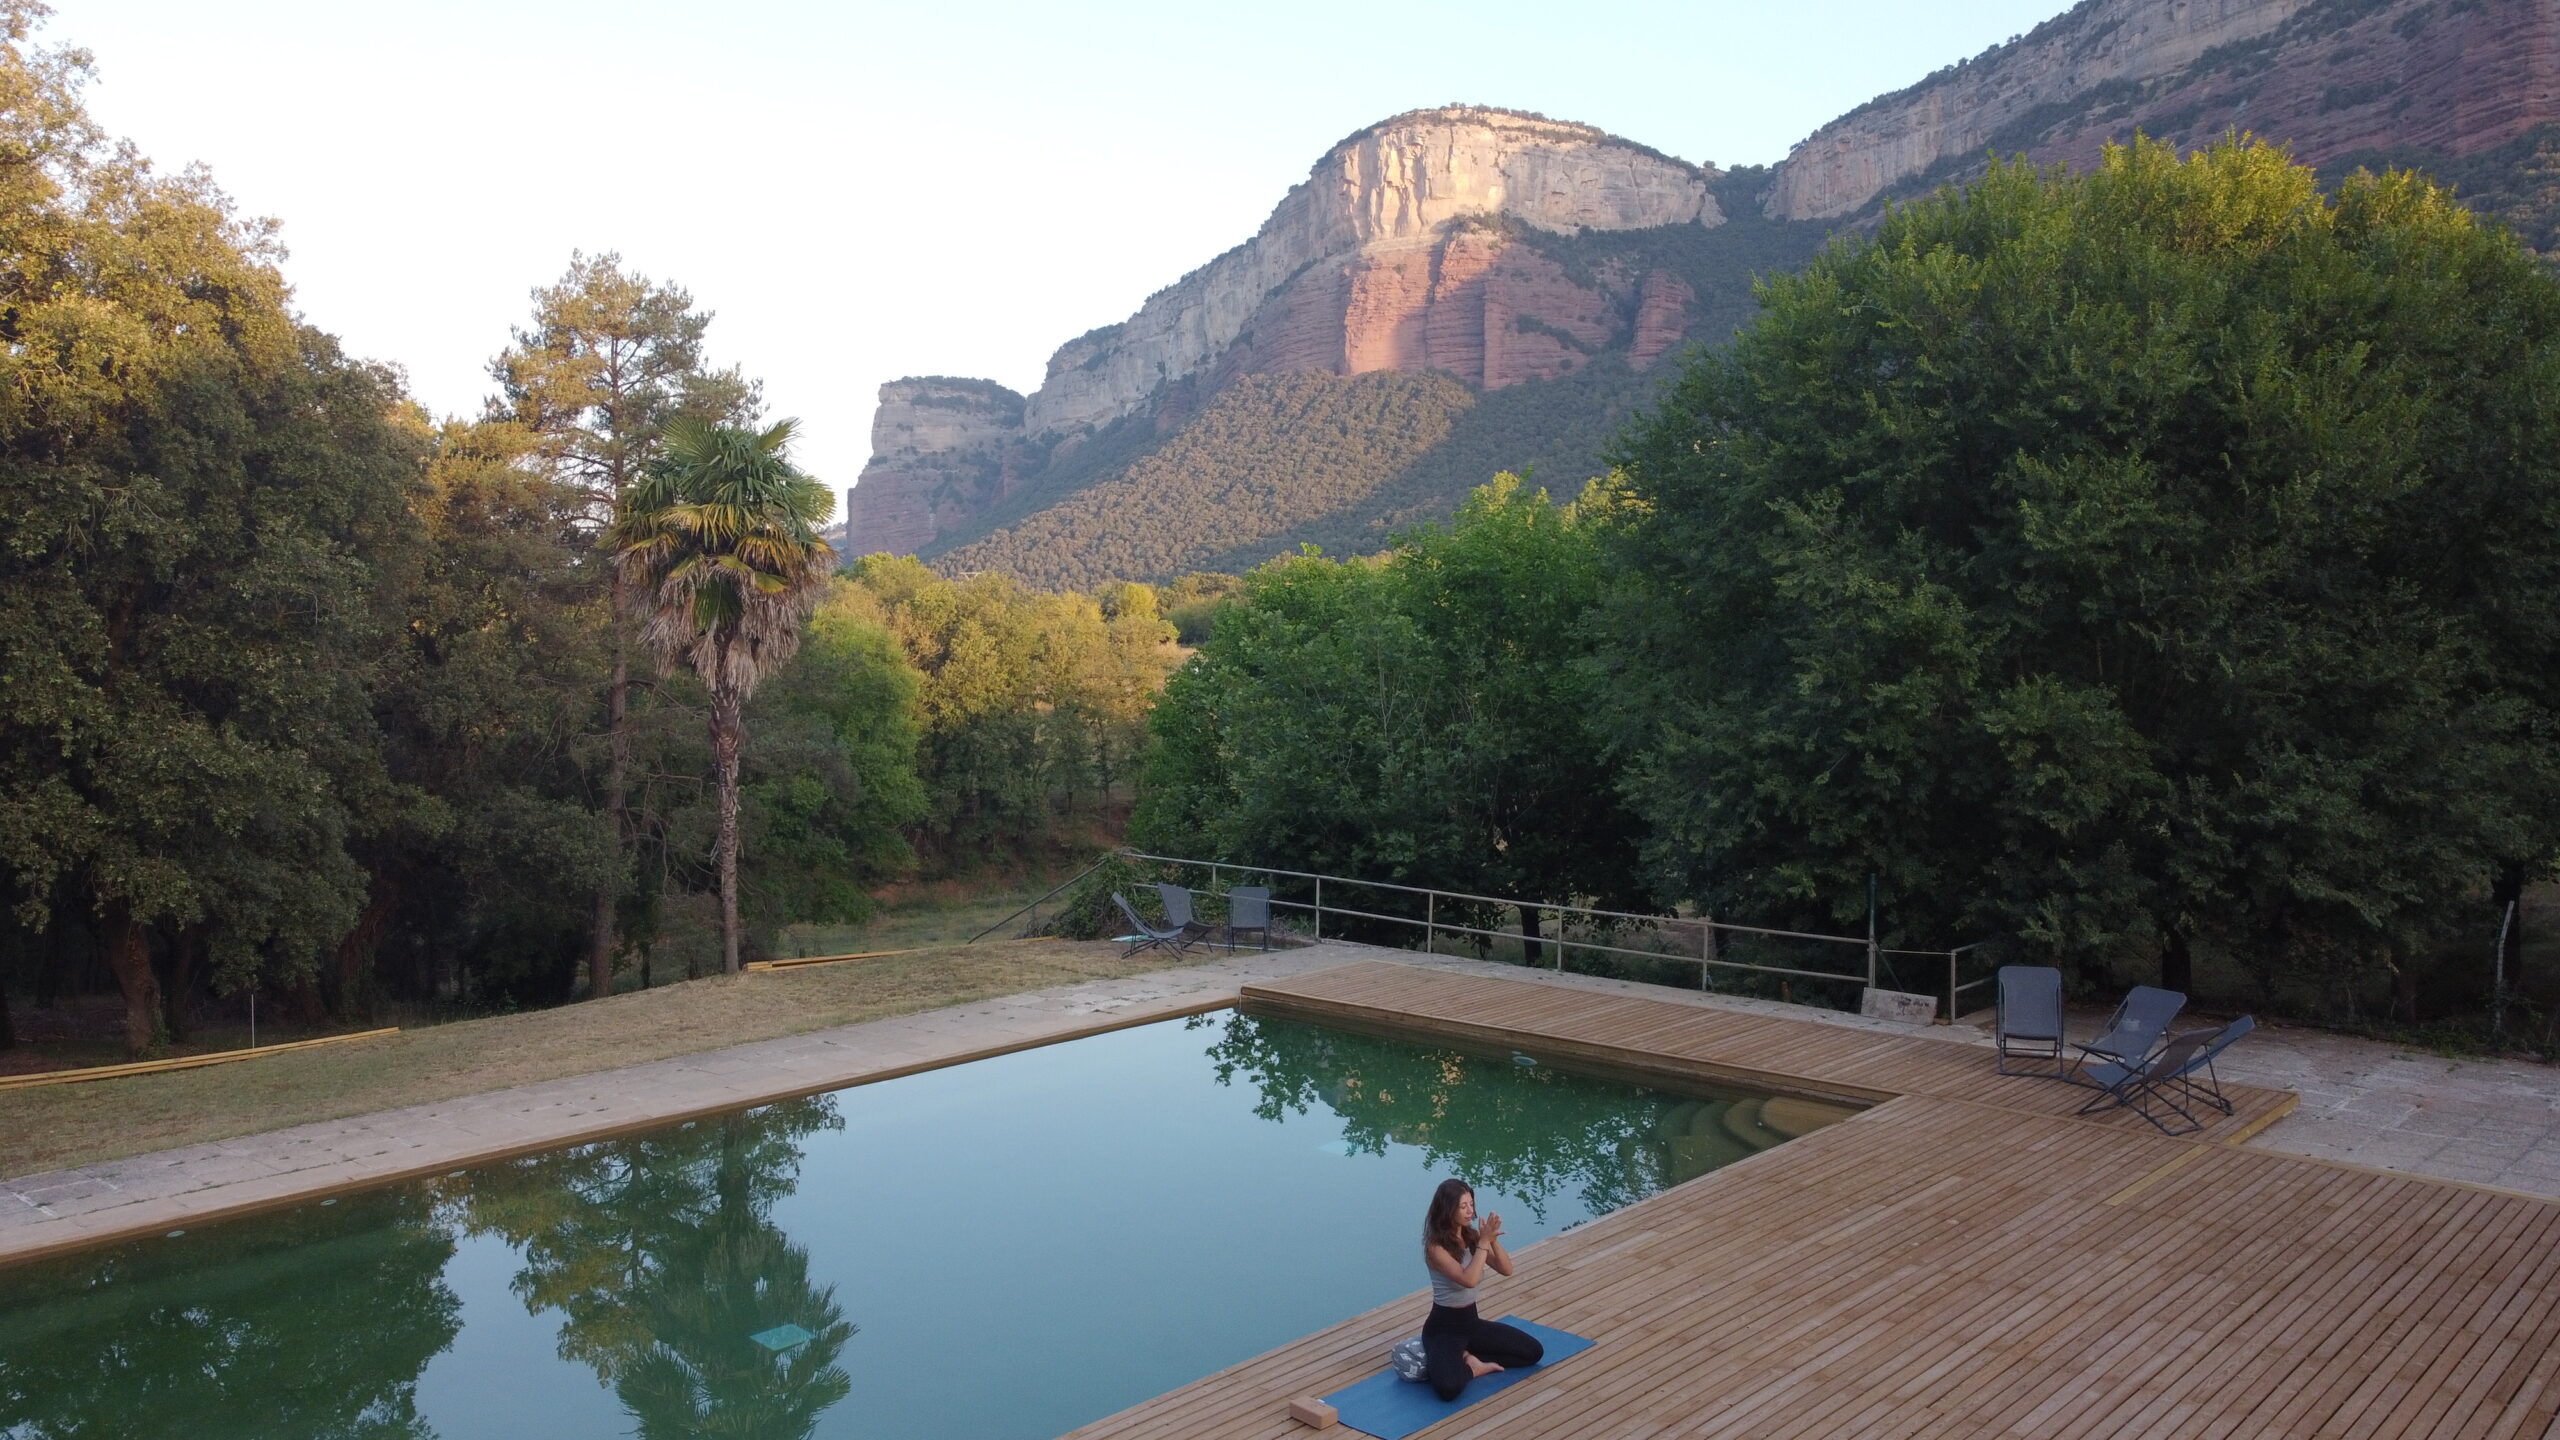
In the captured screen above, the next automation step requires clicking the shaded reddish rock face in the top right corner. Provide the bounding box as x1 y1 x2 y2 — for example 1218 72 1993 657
2033 0 2560 167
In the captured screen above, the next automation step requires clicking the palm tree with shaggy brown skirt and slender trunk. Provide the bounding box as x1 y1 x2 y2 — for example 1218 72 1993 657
604 420 835 974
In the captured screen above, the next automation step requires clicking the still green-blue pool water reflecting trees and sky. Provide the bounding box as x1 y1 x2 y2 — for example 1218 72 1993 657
0 1012 1846 1440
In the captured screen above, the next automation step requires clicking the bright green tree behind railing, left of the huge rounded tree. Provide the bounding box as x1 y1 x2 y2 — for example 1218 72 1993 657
1132 477 1644 935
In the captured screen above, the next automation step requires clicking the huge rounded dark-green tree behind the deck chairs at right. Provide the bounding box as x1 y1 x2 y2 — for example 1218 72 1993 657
1600 141 2560 989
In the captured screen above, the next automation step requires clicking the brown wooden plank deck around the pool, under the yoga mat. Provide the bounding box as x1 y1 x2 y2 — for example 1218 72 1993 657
1075 963 2560 1440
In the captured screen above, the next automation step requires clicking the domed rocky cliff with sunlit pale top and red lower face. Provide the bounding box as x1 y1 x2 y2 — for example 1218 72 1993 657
847 108 1725 551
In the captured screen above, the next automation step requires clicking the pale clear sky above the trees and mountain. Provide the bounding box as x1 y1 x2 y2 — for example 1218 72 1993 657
55 0 2066 504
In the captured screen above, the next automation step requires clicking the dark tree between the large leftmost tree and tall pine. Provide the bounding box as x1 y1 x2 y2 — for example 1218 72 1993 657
360 420 627 1012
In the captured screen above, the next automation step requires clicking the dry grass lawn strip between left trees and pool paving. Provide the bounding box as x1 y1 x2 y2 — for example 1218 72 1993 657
0 940 1187 1176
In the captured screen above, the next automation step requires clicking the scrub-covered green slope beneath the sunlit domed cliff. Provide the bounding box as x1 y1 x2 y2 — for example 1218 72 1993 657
924 203 1830 589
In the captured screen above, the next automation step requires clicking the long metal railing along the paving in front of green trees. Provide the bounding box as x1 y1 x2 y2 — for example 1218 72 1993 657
1131 851 1992 1025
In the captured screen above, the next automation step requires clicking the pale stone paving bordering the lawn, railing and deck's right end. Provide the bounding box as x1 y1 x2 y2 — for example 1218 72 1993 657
15 943 2560 1266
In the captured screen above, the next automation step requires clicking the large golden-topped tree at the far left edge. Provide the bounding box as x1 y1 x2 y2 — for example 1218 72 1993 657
0 3 440 1051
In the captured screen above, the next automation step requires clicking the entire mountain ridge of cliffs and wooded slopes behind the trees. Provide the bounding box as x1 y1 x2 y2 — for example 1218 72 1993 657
845 0 2560 584
